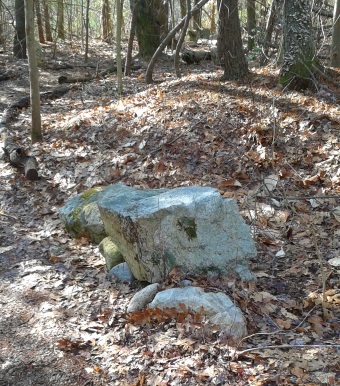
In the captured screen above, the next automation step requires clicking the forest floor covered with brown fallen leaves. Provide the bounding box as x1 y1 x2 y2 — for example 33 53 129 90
0 42 340 386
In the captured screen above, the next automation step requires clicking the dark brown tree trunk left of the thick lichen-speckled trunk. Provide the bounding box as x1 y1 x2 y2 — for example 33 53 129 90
217 0 248 80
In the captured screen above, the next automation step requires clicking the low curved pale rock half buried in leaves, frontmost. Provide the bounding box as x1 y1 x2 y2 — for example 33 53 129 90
148 287 247 339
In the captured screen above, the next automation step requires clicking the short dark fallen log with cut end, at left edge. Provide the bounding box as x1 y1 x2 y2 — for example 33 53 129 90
3 133 39 181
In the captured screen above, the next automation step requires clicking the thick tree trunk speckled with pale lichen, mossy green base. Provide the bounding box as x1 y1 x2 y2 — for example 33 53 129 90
278 0 317 90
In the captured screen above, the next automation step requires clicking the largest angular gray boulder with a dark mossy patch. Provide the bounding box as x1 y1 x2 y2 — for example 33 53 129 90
97 184 256 283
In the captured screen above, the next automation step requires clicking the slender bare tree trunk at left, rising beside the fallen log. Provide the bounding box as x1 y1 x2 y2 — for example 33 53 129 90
25 0 42 143
